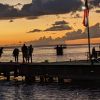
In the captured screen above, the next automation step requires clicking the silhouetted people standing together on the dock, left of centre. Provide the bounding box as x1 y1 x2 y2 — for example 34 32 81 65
13 44 33 63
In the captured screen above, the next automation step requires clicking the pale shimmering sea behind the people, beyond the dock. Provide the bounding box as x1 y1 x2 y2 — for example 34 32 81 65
0 45 98 62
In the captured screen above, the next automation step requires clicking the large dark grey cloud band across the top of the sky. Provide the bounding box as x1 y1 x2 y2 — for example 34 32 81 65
0 0 100 19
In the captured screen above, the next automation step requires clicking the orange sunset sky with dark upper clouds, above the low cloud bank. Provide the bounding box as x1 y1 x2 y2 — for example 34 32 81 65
0 0 100 45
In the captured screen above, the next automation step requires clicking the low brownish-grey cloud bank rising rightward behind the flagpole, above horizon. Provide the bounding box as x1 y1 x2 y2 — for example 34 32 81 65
27 23 100 46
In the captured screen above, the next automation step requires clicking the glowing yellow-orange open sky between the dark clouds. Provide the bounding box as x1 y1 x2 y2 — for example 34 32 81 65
0 0 100 45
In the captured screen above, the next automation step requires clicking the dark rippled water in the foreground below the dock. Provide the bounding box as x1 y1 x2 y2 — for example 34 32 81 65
0 82 100 100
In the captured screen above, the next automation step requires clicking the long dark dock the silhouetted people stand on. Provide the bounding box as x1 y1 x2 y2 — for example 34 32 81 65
0 61 100 82
